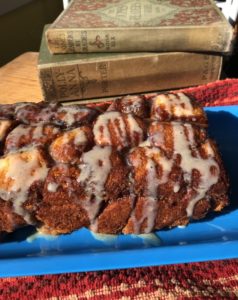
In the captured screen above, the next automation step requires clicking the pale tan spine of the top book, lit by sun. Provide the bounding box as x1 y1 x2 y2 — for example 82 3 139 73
46 24 232 54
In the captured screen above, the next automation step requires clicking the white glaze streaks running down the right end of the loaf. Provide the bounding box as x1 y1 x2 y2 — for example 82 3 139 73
129 118 219 232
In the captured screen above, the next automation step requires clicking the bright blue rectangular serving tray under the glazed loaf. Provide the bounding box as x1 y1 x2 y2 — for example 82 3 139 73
0 106 238 277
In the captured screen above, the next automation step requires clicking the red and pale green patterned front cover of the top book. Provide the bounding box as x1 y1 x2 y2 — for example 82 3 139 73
52 0 224 28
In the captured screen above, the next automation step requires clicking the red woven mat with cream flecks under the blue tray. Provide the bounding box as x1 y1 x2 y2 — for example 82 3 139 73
0 79 238 300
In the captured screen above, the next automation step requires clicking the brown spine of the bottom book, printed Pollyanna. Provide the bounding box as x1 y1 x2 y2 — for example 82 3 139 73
38 53 222 101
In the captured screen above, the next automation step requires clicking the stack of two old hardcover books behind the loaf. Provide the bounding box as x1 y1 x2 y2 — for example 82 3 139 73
38 0 233 101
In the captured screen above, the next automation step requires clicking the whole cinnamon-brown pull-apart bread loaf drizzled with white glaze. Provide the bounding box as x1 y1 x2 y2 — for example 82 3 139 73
0 93 229 234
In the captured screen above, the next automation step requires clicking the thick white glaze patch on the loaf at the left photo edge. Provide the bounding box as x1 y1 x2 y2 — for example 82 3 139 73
0 148 48 224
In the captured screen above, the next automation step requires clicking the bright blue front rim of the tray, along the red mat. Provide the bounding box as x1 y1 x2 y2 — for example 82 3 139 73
0 238 238 278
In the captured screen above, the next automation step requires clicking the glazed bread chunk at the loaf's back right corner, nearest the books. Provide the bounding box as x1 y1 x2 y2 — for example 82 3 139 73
151 93 207 125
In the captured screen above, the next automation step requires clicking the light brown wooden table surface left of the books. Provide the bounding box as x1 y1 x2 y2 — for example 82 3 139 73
0 52 43 103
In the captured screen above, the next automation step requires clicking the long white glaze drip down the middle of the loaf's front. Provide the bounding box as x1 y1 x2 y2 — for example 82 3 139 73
77 146 112 231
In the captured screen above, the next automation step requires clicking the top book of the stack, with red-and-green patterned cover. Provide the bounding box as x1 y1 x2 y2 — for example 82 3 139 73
46 0 233 53
